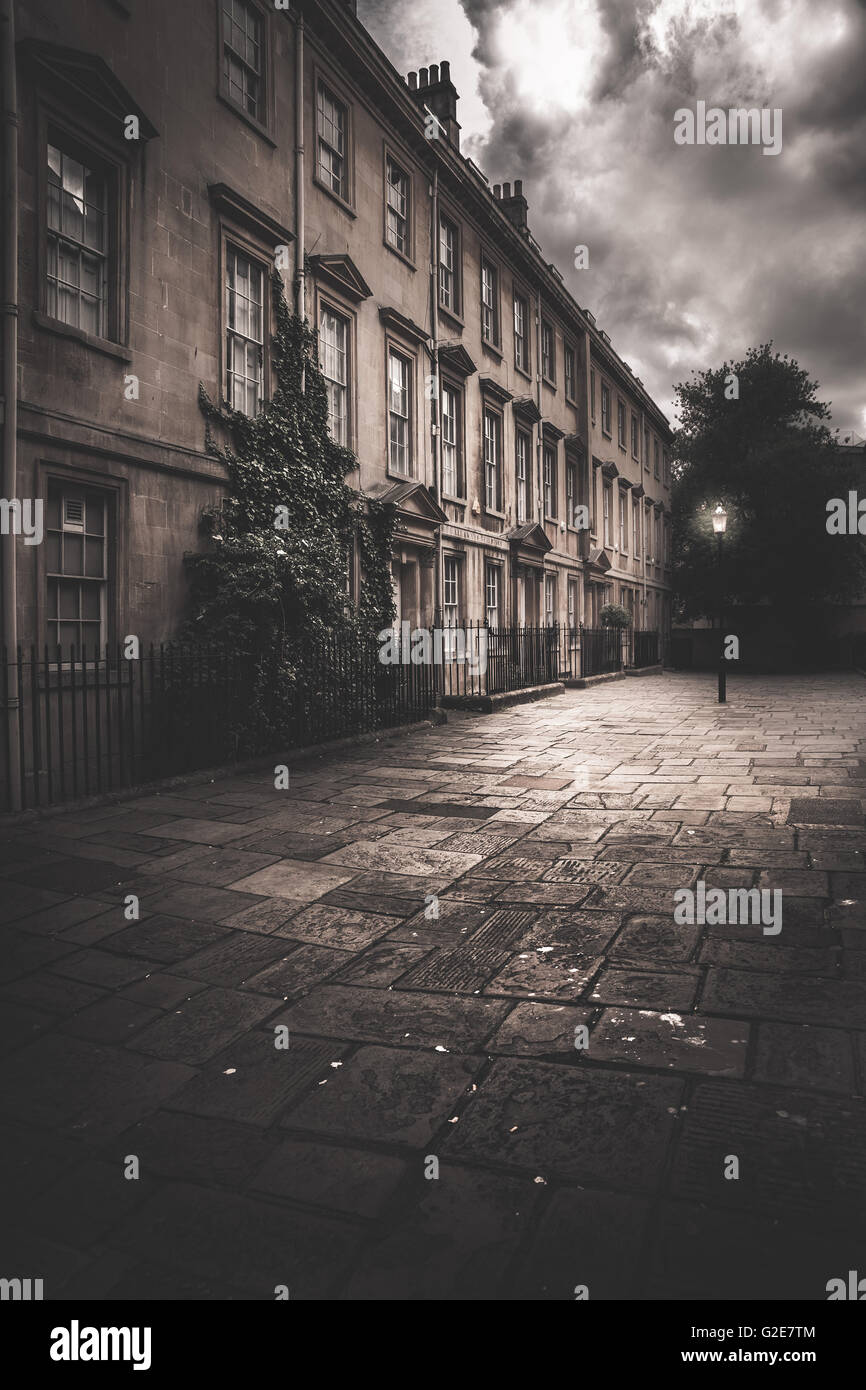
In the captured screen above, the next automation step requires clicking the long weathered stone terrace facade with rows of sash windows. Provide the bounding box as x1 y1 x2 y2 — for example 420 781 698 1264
3 0 670 644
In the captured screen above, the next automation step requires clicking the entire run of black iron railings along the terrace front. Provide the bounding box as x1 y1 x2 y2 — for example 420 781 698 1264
0 623 659 810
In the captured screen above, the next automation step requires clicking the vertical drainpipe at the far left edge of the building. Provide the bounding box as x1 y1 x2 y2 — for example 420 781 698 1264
0 0 21 810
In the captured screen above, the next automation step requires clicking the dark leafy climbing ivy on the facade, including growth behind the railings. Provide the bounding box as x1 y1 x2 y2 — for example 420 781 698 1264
177 274 395 753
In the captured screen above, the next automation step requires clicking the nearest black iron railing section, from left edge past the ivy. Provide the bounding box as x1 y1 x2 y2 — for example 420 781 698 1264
0 637 436 810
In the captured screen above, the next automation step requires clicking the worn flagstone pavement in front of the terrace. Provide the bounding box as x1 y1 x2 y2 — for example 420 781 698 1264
0 673 866 1300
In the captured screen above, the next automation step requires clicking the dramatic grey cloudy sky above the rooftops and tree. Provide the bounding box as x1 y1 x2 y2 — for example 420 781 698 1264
359 0 866 435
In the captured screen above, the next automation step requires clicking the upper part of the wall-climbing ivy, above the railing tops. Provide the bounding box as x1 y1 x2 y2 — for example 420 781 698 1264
185 274 393 655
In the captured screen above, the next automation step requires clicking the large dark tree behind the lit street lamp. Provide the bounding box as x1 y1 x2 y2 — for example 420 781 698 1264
673 342 866 628
